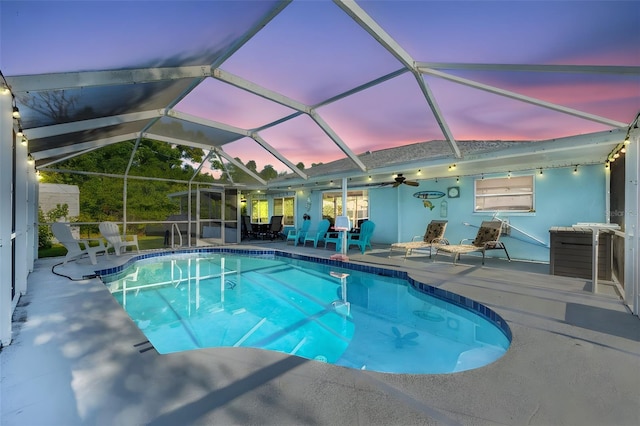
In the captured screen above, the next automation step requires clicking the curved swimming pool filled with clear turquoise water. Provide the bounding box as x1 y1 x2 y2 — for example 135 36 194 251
98 249 511 374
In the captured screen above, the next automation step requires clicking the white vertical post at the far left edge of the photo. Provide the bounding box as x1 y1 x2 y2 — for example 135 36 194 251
0 88 14 346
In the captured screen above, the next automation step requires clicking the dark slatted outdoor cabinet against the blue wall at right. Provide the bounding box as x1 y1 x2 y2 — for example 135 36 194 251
549 226 612 281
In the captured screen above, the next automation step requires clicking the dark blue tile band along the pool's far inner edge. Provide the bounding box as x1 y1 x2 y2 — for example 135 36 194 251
95 247 512 342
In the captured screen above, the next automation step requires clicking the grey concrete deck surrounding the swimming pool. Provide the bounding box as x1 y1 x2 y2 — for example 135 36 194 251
0 242 640 426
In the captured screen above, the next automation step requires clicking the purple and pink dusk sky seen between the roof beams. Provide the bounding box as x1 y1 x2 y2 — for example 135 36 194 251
0 0 640 170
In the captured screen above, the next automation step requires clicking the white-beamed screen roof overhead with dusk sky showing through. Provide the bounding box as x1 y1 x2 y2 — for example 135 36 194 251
0 0 640 186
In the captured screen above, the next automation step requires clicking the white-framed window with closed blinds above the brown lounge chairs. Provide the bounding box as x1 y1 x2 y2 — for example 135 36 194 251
474 176 535 212
